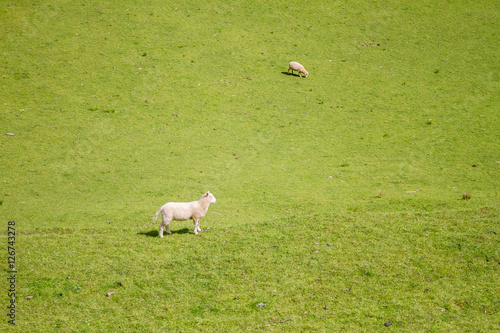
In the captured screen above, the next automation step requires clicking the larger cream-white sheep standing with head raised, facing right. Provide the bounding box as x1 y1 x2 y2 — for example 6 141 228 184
153 192 216 237
